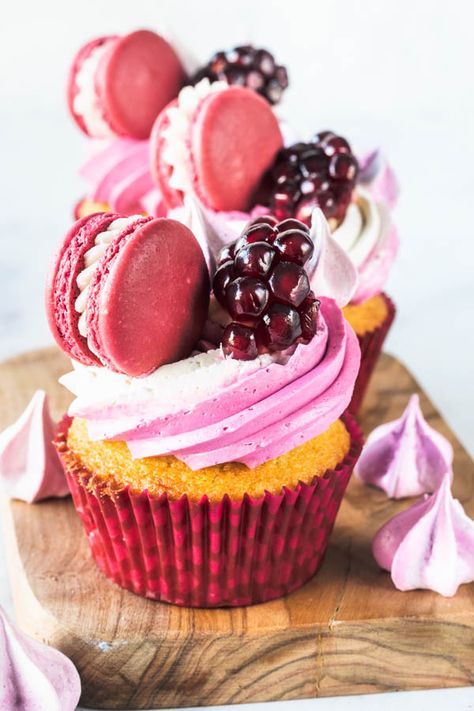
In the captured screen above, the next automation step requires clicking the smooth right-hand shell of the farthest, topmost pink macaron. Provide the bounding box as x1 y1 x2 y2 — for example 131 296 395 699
96 30 185 138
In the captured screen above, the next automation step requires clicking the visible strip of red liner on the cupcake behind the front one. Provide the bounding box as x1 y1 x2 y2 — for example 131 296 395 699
348 292 396 415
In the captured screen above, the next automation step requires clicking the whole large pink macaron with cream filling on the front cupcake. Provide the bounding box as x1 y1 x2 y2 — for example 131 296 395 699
46 213 210 376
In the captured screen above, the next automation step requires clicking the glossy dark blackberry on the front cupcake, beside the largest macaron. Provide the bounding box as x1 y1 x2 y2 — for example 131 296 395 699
213 216 319 360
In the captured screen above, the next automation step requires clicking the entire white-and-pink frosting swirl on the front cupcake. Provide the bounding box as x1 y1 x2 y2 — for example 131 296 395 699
61 298 360 469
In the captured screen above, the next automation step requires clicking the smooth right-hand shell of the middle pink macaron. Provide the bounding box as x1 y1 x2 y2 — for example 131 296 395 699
190 86 283 211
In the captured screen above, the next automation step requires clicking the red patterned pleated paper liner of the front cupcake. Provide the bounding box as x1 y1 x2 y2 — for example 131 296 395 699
56 414 362 608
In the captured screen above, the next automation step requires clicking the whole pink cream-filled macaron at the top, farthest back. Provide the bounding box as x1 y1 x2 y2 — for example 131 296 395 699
67 30 185 138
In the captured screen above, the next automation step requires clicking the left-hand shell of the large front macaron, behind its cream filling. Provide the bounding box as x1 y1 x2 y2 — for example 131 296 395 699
45 213 118 365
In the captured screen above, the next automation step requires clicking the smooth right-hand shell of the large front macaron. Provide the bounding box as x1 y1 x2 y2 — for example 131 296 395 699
87 218 210 376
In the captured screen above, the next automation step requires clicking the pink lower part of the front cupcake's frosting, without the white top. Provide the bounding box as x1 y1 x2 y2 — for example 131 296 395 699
71 298 360 470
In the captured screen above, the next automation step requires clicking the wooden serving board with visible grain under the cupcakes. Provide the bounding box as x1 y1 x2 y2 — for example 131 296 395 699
0 349 474 709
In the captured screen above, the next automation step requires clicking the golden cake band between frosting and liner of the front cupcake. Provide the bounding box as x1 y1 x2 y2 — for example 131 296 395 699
67 418 350 501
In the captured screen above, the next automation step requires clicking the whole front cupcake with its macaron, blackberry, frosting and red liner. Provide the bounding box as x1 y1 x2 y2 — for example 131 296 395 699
47 206 361 607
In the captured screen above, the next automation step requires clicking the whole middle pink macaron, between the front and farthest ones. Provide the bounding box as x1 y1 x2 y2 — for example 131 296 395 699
150 79 283 211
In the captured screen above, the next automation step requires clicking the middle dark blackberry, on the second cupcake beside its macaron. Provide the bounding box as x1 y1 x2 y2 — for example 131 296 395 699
258 131 359 225
